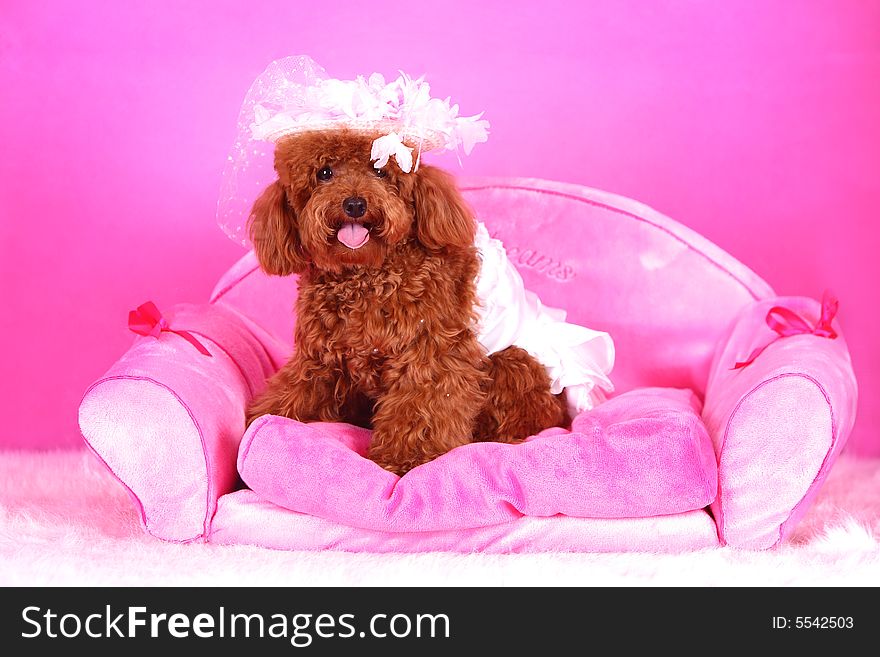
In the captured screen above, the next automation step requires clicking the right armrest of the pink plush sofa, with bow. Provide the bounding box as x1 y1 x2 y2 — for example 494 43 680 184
703 297 858 549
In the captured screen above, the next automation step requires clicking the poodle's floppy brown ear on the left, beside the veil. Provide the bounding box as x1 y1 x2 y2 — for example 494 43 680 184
249 180 308 276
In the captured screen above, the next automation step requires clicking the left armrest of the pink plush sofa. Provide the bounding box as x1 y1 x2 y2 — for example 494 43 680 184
79 304 277 542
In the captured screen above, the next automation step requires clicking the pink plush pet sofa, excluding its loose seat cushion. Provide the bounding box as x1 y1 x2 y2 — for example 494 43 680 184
80 179 857 552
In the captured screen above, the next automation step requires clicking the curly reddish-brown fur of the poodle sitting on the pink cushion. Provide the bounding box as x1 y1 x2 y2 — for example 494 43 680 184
247 129 568 474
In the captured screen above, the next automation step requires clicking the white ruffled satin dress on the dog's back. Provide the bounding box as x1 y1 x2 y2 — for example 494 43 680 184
475 223 614 417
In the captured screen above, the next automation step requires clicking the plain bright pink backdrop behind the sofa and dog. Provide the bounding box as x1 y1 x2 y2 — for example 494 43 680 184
0 0 880 455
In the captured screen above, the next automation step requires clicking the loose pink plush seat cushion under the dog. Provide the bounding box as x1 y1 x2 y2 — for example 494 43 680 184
238 388 717 532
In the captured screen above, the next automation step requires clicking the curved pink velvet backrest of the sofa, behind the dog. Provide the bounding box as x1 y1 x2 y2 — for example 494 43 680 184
212 174 773 395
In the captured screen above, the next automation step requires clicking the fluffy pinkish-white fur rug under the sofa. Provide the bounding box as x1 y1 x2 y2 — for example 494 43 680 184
0 451 880 586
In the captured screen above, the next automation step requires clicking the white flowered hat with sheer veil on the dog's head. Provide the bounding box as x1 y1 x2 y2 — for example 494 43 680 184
217 55 489 246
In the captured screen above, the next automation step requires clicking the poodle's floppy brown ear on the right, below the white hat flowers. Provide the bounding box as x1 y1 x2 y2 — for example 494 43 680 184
412 166 476 249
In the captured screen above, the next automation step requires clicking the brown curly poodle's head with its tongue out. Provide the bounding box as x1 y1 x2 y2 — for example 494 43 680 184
250 129 475 276
